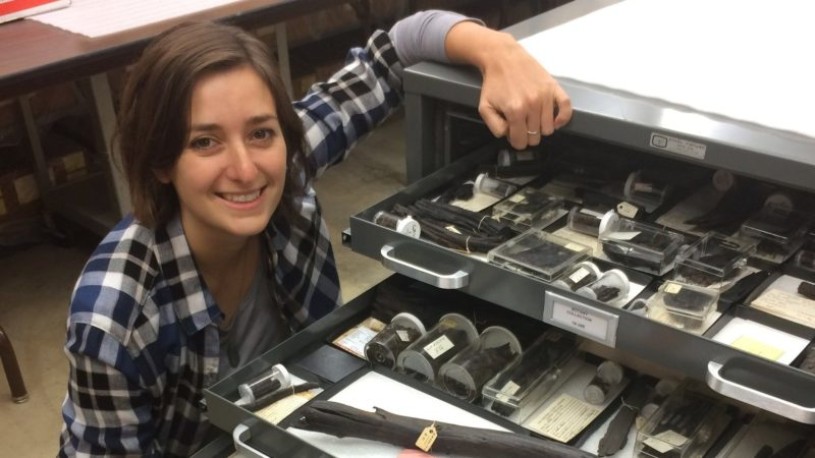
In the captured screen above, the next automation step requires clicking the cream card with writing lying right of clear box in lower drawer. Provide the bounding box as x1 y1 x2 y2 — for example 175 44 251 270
525 394 603 443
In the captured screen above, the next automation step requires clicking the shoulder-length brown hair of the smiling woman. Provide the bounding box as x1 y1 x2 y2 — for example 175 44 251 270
115 22 306 228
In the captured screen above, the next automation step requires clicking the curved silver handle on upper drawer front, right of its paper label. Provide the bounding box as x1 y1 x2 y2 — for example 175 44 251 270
705 360 815 424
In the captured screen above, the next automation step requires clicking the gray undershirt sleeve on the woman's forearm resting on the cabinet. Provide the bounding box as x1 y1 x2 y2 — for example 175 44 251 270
388 10 483 67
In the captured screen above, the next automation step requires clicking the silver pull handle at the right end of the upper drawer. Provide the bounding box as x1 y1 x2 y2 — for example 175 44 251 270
706 358 815 424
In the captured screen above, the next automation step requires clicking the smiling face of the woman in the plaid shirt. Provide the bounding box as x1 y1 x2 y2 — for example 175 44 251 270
159 66 286 247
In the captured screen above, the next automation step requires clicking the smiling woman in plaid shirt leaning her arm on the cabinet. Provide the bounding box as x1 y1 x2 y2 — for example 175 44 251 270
55 11 571 456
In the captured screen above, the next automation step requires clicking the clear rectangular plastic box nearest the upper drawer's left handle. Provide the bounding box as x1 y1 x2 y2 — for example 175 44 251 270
487 229 591 281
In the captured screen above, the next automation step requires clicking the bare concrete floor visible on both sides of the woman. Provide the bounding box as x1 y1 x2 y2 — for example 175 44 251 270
0 110 405 457
